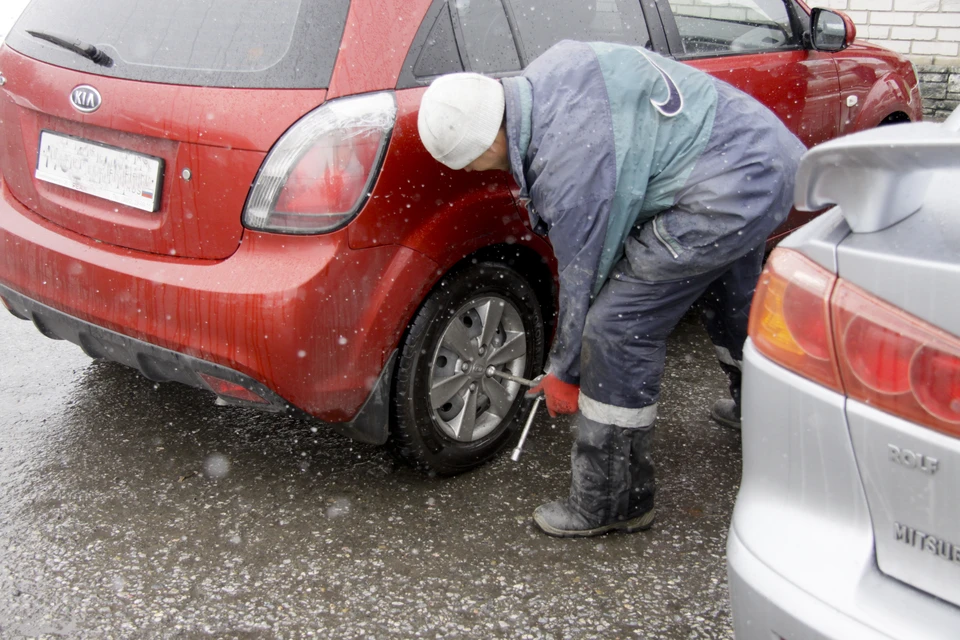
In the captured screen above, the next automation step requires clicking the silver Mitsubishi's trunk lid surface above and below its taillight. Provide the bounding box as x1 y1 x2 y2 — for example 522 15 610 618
837 169 960 605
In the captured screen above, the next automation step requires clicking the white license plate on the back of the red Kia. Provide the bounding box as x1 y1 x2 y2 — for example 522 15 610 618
35 131 163 211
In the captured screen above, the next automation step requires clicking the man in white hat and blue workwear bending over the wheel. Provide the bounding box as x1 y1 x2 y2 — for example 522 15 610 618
418 41 804 537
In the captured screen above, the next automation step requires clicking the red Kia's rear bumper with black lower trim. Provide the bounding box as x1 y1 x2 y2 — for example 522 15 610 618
0 185 437 436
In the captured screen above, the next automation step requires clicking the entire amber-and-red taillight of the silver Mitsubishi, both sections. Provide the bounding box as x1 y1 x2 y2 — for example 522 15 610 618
749 249 960 436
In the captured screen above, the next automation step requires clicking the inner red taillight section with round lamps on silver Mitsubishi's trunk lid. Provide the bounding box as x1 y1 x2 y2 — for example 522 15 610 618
833 281 960 436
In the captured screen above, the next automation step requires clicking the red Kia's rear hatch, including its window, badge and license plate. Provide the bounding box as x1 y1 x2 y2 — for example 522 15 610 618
0 0 349 259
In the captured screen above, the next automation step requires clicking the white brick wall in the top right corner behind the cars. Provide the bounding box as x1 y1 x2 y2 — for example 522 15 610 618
808 0 960 120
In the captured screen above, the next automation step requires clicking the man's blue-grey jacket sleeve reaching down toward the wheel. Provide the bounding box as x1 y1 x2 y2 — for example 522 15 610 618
518 41 617 383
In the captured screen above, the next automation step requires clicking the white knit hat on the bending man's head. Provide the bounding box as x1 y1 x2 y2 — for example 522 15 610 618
417 73 503 169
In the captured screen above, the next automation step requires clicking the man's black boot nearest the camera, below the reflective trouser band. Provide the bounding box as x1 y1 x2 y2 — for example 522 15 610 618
533 415 655 538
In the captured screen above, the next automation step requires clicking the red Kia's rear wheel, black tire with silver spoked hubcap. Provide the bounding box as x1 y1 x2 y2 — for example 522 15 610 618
388 262 544 475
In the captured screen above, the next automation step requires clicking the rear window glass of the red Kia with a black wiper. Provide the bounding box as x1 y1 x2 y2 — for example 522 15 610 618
6 0 350 89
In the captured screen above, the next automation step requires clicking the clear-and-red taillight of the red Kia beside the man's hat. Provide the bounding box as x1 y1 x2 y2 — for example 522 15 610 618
243 93 397 234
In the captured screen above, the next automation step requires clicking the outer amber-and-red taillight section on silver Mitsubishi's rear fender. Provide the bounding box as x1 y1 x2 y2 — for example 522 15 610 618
749 249 840 391
